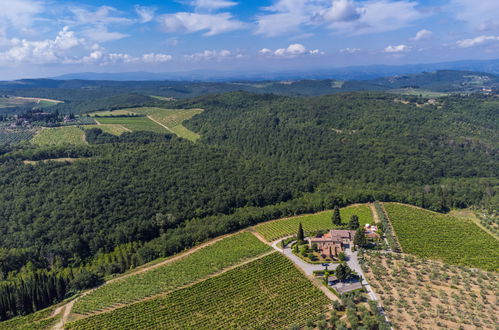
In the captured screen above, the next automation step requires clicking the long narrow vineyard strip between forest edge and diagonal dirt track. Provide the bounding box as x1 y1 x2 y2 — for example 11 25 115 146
73 232 271 314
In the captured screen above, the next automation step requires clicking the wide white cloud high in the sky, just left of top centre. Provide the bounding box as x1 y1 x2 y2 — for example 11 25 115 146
160 12 246 36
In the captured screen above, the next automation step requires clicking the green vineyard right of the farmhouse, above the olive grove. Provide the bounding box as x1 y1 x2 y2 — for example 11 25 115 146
384 203 499 271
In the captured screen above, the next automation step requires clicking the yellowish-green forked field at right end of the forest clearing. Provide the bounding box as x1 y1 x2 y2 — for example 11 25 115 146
125 108 203 141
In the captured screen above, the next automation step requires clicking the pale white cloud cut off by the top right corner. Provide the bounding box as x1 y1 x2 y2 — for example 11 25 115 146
448 0 499 31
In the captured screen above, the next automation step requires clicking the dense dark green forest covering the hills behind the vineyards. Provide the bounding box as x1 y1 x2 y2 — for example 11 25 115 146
0 88 499 319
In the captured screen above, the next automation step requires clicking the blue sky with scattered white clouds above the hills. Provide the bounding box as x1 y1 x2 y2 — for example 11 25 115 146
0 0 499 80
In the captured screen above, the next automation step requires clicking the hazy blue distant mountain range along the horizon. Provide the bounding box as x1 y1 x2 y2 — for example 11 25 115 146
49 59 499 82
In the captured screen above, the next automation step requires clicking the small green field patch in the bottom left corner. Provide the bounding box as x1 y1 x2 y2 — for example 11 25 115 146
0 306 61 330
